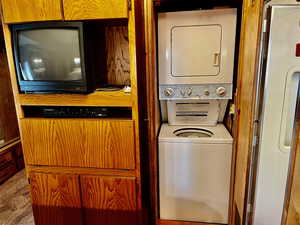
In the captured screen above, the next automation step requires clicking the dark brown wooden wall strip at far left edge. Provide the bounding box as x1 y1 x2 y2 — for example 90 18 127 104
0 22 19 145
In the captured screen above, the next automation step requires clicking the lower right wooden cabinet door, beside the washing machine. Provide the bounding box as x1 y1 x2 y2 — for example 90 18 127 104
80 176 137 225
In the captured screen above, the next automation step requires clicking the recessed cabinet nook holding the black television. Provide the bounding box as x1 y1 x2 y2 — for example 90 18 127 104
11 20 130 94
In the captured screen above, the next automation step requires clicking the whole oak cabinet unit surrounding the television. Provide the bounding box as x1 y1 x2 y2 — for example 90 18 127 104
0 0 147 225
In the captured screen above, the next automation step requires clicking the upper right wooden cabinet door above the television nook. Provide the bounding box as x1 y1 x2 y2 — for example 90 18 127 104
63 0 128 20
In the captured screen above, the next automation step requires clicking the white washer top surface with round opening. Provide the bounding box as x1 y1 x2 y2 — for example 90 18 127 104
159 124 233 144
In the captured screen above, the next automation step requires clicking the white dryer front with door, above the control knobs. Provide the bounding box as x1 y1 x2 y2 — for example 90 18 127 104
158 9 237 85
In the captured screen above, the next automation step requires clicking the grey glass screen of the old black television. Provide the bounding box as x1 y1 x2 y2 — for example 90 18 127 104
17 28 83 81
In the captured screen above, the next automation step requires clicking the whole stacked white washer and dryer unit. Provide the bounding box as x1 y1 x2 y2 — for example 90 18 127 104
158 9 237 224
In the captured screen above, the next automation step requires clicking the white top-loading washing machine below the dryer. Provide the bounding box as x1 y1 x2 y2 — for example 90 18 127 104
159 124 233 224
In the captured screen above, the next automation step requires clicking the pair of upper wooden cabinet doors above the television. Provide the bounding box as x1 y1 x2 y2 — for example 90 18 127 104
1 0 131 23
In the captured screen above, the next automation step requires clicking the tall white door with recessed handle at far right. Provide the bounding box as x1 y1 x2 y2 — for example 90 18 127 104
254 5 300 225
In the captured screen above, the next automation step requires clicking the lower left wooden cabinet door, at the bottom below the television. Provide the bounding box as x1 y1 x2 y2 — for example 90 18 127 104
30 172 82 225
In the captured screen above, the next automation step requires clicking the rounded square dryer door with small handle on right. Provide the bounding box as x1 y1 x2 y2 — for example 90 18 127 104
171 25 222 77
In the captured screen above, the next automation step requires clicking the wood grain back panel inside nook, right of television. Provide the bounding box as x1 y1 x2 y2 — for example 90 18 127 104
105 26 130 85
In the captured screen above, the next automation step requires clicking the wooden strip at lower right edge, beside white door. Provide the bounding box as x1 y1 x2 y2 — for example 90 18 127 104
282 86 300 225
